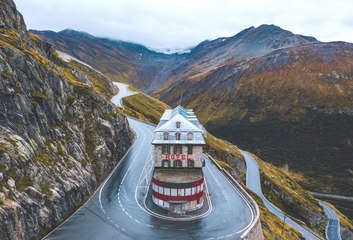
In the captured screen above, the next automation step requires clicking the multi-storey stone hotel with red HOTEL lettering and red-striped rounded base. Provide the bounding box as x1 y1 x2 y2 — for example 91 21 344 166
151 106 205 214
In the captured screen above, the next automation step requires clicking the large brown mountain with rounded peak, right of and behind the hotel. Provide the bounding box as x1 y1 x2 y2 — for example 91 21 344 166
32 21 353 218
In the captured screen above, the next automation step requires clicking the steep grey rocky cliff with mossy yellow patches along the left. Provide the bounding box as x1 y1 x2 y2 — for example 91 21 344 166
0 0 132 239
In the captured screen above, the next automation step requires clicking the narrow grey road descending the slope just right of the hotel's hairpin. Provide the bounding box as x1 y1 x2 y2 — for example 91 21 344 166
241 150 320 240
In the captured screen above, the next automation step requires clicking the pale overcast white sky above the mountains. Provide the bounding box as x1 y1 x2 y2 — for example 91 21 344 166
15 0 353 49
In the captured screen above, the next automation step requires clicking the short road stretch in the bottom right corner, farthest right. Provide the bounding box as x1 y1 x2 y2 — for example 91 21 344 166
320 201 342 240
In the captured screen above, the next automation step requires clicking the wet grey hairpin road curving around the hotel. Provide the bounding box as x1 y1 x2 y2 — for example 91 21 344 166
45 119 254 240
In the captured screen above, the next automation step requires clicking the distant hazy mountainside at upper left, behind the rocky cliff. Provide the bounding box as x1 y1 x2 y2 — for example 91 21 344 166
32 30 183 89
